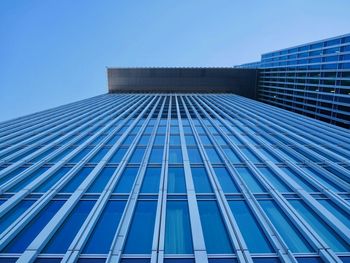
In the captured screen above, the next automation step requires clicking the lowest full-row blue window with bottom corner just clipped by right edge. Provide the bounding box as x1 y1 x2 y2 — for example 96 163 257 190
289 200 350 252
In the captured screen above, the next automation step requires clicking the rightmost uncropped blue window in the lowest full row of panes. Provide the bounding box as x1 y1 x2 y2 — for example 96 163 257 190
259 200 313 253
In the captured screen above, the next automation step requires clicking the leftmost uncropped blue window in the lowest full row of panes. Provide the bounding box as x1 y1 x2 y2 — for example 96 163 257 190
2 201 64 253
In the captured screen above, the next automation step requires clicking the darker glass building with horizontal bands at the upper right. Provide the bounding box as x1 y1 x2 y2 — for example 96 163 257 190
240 34 350 128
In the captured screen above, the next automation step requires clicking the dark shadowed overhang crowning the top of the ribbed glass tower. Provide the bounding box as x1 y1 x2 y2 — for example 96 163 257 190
107 68 257 99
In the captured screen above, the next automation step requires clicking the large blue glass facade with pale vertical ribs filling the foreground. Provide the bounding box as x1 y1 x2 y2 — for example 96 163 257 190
0 94 350 263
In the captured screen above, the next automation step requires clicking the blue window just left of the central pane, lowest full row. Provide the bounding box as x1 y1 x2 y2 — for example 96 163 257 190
124 201 157 254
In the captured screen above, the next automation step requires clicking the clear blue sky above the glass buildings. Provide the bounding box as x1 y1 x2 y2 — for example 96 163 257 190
0 0 350 121
